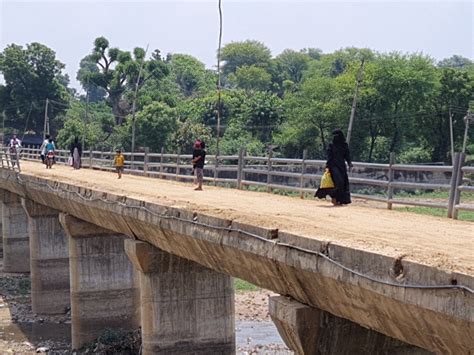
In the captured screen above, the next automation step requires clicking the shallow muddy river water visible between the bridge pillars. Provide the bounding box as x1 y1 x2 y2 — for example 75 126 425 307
0 321 291 354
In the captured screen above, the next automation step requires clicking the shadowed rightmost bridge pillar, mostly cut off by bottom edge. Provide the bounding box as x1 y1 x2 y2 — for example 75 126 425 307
269 296 431 355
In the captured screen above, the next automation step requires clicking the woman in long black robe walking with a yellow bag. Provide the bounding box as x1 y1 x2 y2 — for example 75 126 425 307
315 129 352 206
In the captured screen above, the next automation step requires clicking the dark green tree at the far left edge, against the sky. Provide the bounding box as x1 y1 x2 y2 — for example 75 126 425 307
0 43 68 132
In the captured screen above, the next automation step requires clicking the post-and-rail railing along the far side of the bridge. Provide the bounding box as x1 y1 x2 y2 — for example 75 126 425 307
16 147 474 218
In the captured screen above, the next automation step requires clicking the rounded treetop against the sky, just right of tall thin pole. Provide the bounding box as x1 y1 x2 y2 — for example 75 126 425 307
221 40 272 76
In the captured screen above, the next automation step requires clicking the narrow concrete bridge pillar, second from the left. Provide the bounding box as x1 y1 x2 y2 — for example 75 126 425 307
21 199 71 314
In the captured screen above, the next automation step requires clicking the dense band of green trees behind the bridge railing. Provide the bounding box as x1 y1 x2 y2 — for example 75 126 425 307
0 37 474 162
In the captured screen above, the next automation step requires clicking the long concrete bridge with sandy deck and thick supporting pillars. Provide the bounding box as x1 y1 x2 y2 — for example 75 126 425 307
0 162 474 354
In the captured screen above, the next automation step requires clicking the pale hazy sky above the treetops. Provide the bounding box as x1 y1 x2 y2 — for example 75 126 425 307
0 0 474 89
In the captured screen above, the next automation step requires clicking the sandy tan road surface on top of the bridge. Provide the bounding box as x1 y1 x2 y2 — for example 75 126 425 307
14 161 474 275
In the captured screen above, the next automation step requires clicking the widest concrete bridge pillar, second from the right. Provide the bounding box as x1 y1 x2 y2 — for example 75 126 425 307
125 240 235 355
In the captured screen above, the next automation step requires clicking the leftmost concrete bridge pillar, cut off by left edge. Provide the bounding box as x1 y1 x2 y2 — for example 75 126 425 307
1 190 30 272
